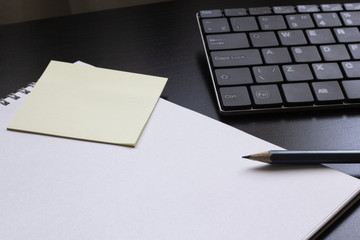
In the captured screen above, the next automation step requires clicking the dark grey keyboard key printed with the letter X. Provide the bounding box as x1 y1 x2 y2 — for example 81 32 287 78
312 63 343 80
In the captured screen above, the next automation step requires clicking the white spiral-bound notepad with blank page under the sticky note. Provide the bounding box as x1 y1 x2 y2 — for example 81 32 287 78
0 86 360 240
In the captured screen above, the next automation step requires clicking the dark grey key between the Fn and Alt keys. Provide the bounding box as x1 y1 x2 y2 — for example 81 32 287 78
282 83 314 106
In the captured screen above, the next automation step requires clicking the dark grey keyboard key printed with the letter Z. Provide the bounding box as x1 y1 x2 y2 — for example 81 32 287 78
282 64 314 81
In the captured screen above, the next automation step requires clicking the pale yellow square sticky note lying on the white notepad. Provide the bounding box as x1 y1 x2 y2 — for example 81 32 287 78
8 61 167 146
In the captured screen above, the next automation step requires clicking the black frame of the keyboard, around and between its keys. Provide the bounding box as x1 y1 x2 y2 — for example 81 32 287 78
196 4 360 115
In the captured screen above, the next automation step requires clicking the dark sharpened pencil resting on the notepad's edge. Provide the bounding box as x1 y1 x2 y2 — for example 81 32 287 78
243 150 360 164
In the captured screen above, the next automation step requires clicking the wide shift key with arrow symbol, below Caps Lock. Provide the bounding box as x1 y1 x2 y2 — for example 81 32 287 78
215 68 253 86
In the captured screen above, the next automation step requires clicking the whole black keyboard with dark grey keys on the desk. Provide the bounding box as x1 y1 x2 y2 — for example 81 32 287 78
197 3 360 115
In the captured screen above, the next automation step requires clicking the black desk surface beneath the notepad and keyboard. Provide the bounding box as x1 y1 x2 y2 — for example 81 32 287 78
0 0 360 239
